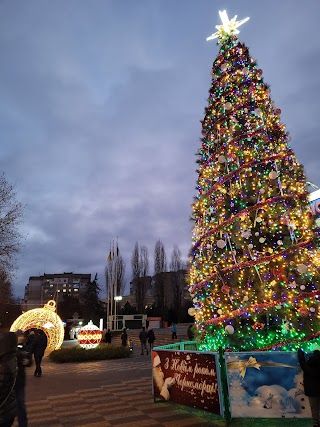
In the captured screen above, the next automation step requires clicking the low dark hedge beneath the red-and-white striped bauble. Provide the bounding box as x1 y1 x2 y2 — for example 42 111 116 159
49 344 131 363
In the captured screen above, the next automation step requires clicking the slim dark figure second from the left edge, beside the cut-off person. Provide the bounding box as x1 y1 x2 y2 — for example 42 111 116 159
15 329 32 427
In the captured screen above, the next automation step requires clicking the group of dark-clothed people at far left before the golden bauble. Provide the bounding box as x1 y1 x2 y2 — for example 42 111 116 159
0 330 47 427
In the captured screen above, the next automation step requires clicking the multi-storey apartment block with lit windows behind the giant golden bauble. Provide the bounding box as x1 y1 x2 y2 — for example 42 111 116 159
23 273 91 310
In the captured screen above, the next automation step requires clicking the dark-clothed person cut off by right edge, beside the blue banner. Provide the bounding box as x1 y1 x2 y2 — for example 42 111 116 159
298 349 320 427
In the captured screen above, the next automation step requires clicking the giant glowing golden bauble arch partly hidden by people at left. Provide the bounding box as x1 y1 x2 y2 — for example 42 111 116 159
10 300 64 350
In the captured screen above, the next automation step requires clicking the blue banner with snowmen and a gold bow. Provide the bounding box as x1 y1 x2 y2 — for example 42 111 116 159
225 351 311 418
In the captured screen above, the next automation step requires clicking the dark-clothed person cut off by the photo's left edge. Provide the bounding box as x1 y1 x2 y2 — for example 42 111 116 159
0 332 18 427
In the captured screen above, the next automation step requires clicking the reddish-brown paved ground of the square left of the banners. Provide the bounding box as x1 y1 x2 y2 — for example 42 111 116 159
14 348 219 427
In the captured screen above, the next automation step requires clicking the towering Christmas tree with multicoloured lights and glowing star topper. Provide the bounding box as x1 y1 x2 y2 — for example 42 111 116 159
189 11 320 350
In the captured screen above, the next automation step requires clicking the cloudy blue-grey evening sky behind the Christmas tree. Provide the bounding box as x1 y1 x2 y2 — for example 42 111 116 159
0 0 320 296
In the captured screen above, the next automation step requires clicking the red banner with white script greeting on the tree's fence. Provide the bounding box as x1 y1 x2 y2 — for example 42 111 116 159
152 348 223 415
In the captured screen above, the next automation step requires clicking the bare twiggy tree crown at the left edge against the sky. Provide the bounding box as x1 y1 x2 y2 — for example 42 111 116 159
0 174 23 271
